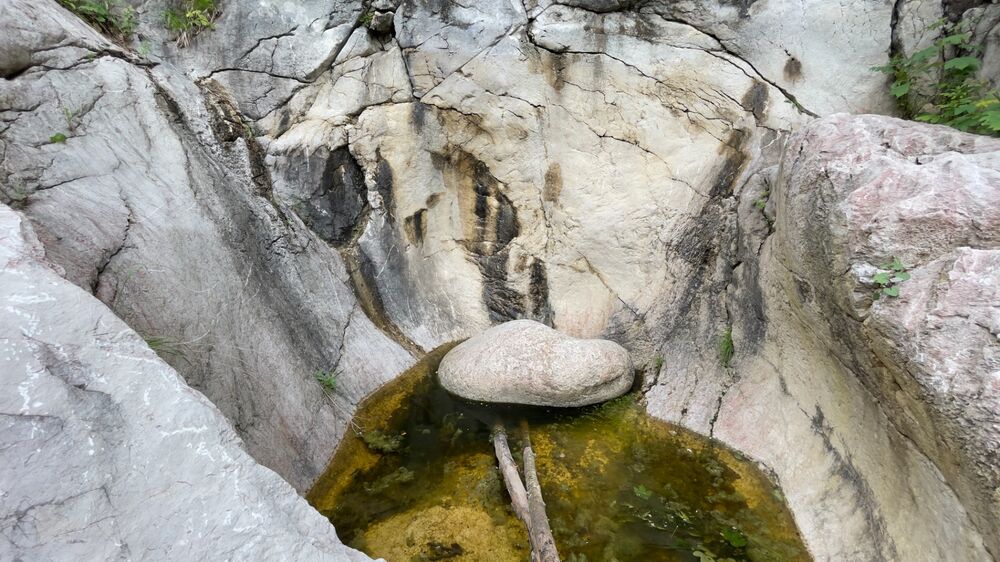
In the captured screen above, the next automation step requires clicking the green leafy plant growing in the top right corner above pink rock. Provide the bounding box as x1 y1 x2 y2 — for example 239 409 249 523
872 20 1000 136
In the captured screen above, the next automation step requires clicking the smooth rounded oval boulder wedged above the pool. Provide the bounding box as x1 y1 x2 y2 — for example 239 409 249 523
438 320 635 407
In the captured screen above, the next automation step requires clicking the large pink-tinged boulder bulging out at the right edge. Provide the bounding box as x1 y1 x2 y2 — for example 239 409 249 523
776 115 1000 552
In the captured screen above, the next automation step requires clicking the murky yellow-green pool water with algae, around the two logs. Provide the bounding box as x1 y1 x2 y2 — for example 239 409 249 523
308 349 810 562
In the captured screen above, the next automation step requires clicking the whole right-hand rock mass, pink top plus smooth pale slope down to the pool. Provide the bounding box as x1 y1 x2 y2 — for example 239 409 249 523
646 115 1000 561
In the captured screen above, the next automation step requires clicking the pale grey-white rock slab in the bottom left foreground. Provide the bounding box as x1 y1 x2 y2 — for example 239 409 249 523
0 205 370 561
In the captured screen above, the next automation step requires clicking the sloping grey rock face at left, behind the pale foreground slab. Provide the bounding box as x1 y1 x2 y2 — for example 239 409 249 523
0 1 413 490
